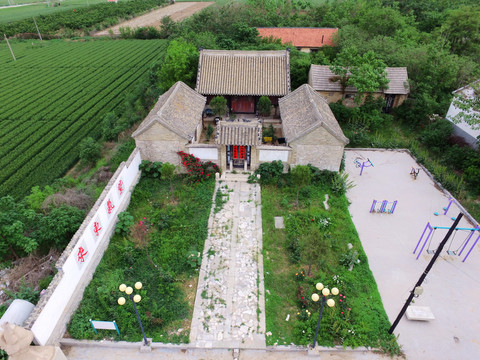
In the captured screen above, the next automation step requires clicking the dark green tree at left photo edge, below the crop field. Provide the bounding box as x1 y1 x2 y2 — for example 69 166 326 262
0 196 38 259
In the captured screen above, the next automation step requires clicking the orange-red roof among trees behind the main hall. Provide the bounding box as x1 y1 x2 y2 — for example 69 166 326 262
257 28 338 48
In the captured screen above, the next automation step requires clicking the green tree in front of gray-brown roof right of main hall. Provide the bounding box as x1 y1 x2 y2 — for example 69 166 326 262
330 47 389 104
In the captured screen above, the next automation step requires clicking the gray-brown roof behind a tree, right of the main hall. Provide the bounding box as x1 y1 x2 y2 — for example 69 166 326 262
308 65 410 94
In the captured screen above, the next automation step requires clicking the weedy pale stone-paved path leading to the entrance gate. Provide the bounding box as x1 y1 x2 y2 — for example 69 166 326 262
190 174 265 348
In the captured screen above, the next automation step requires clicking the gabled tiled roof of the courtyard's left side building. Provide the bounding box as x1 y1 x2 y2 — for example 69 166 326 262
132 81 207 140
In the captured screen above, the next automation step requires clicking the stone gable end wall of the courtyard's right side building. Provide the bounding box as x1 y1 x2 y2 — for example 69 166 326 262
289 127 344 171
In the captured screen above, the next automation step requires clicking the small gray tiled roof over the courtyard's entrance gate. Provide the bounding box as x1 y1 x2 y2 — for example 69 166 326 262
215 121 262 146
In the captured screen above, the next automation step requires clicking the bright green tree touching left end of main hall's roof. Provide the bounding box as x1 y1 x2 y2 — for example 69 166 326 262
158 39 198 91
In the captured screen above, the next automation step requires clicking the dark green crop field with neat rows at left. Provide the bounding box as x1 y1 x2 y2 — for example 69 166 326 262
0 40 167 200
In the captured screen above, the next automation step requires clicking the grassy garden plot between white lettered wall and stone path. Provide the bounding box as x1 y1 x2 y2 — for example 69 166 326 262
68 177 214 343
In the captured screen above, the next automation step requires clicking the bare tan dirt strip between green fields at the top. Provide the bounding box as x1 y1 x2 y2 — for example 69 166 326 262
94 1 215 36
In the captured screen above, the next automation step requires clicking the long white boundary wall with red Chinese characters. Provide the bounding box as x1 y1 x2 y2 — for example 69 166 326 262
26 149 141 345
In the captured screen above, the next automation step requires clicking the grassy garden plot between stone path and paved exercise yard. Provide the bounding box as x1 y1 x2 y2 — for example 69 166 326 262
262 172 399 352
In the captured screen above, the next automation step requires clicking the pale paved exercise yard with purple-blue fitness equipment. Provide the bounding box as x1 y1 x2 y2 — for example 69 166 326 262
345 149 480 360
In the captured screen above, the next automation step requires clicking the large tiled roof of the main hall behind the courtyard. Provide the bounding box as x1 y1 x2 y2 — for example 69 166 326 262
195 50 290 96
